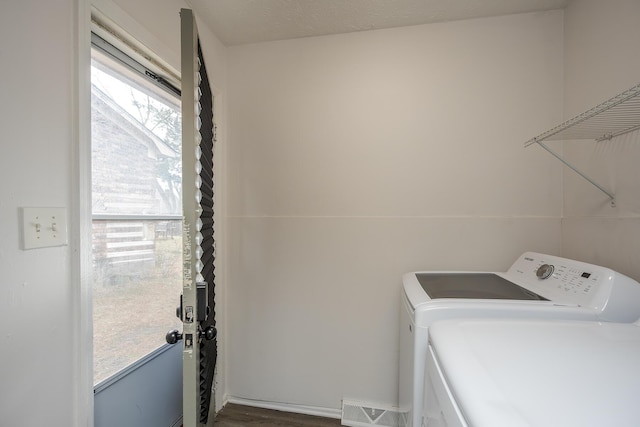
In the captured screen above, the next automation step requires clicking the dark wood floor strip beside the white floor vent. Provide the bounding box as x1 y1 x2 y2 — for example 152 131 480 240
214 403 341 427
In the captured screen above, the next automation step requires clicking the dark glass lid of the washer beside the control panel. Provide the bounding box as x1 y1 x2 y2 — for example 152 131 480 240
415 273 548 301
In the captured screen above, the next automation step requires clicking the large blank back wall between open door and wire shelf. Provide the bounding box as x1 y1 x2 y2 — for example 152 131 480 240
227 11 563 410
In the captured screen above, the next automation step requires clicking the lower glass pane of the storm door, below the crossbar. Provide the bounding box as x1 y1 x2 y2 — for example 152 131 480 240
93 220 182 383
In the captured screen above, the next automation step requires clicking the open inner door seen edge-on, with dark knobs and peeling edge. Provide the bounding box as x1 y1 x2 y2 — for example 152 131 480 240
167 9 217 427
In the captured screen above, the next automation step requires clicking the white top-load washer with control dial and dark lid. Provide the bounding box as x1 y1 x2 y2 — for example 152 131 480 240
399 252 640 427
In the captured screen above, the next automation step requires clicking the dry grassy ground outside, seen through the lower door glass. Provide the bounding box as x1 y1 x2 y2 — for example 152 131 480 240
93 236 182 384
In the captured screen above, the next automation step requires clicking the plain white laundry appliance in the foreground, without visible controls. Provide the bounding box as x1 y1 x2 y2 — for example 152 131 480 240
423 319 640 427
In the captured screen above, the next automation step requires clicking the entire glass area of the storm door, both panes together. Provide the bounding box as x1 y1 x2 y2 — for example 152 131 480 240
91 48 182 384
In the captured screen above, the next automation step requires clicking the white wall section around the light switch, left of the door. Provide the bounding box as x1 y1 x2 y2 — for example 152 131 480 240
0 0 81 427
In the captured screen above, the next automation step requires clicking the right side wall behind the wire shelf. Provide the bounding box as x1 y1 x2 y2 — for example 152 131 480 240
562 0 640 280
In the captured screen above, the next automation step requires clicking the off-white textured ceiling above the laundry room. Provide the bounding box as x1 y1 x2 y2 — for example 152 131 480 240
188 0 569 46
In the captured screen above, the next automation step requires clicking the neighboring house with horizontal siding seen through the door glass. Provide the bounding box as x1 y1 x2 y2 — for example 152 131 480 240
91 85 180 281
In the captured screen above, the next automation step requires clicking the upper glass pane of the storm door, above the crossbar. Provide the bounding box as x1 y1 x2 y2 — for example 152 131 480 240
91 59 182 215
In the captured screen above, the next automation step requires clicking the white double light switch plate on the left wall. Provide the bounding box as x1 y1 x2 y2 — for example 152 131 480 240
20 208 68 249
